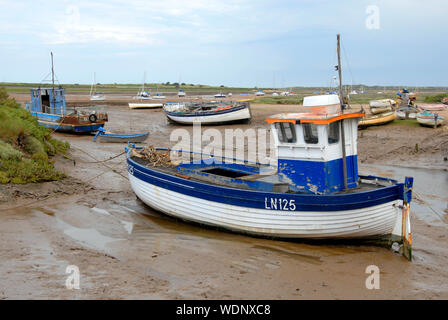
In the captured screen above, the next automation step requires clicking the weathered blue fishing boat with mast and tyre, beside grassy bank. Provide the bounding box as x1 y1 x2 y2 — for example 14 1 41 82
25 53 108 133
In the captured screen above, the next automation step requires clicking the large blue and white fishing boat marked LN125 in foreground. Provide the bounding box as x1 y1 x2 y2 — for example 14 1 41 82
127 36 413 259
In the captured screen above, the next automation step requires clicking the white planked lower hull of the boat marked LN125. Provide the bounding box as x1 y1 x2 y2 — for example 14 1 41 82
129 174 402 239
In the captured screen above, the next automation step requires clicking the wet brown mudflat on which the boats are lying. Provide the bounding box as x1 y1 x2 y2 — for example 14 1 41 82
0 95 448 299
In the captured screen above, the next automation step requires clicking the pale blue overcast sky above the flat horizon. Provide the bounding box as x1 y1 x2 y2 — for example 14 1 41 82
0 0 448 87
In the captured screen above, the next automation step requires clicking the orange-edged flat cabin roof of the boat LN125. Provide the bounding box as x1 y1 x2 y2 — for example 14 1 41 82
266 112 365 124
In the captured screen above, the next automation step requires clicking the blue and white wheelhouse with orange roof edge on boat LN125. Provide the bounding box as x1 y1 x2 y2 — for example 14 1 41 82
267 113 364 194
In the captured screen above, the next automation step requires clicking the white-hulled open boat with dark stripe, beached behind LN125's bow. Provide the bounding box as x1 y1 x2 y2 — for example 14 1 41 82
163 101 251 125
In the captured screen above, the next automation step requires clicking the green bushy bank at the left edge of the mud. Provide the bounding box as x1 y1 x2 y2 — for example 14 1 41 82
0 87 69 184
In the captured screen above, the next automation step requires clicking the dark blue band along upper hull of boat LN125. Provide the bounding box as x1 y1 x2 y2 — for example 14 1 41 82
127 155 403 211
